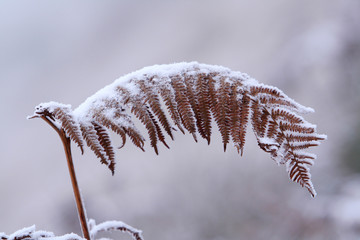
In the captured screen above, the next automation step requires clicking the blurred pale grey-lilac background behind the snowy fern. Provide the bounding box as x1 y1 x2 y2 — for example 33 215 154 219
0 0 360 240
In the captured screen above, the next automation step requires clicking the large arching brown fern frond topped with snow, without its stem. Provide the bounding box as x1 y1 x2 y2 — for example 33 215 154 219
30 62 326 196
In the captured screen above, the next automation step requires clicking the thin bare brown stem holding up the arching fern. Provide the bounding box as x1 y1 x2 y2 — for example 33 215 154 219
41 116 90 240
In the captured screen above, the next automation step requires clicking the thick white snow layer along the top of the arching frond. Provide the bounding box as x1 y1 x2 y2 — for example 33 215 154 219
69 62 314 135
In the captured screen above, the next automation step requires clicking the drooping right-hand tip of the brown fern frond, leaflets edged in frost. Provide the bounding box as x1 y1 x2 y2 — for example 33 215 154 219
252 84 325 196
